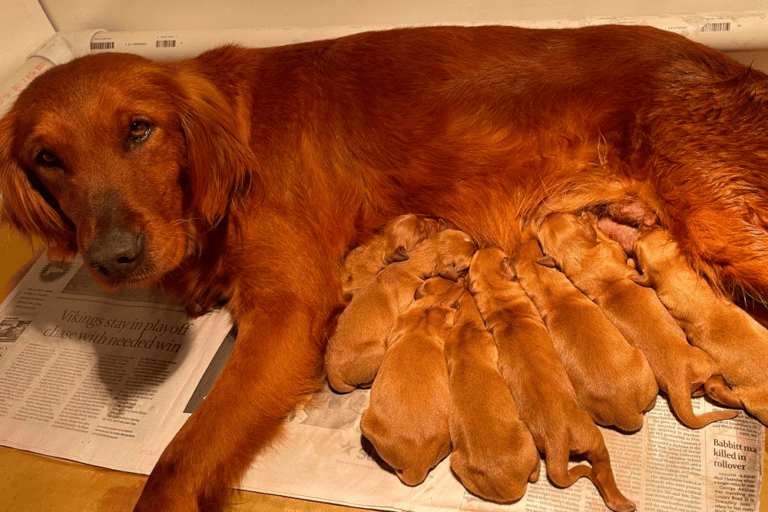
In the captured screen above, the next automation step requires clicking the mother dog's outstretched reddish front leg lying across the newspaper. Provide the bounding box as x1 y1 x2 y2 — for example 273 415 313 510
134 292 326 512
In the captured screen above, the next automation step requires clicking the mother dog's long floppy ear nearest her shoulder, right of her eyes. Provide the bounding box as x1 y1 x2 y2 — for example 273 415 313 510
166 68 258 225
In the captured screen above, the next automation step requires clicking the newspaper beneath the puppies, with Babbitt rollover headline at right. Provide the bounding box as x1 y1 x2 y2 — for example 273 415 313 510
243 387 765 512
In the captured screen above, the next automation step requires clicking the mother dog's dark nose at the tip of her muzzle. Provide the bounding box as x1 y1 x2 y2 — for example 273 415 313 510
86 228 144 278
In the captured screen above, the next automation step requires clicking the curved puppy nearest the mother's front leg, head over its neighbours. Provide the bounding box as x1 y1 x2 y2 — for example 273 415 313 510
325 229 477 393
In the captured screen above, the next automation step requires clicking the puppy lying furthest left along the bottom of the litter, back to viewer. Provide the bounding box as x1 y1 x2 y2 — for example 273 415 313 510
360 277 464 485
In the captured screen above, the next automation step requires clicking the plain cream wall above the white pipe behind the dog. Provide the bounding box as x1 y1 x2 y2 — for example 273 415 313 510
37 0 768 30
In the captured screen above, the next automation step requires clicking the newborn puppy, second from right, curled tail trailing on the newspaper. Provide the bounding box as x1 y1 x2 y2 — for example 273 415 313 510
539 213 739 428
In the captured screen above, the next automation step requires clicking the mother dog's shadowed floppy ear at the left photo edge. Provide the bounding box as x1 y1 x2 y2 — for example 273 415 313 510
0 116 77 261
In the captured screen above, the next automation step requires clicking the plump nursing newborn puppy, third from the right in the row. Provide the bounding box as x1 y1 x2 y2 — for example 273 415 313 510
515 239 658 431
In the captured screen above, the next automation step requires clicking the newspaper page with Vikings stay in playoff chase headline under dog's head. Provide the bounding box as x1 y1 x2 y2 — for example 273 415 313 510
0 257 232 473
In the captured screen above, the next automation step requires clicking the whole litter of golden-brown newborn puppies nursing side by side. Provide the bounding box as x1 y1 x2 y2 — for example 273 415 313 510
326 212 768 512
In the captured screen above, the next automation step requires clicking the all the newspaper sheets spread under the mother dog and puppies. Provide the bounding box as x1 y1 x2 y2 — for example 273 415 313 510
0 254 765 512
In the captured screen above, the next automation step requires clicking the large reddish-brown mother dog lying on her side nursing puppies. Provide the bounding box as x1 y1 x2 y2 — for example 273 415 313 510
0 26 768 512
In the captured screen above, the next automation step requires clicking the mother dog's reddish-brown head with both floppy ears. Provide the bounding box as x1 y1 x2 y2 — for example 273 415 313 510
0 54 253 288
